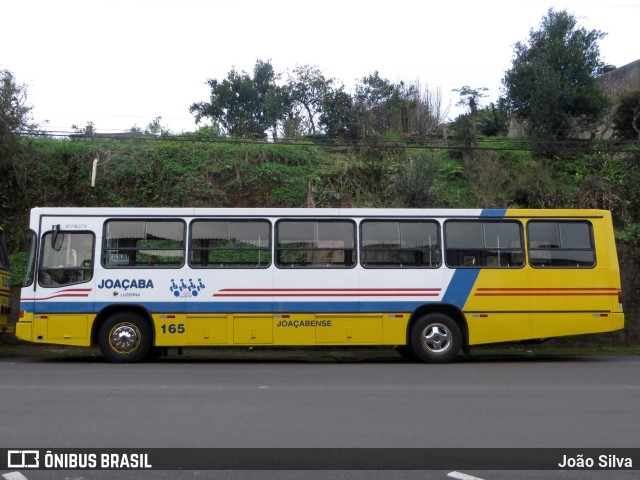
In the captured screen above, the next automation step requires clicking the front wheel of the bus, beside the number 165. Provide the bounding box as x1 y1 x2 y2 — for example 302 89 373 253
98 312 151 363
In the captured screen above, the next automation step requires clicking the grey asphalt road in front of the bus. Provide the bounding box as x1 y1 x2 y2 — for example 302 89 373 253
0 348 640 480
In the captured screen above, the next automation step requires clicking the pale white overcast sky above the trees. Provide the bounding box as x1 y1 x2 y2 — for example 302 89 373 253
0 0 640 133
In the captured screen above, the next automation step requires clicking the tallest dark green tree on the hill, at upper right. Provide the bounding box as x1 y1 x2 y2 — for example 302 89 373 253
502 9 608 147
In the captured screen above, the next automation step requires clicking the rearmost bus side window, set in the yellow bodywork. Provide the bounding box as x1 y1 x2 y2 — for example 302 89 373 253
527 220 596 268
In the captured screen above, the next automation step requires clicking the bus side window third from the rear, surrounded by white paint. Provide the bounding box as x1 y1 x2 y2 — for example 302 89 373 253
360 220 442 268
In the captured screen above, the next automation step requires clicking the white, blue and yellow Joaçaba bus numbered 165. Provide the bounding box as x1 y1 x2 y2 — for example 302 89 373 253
16 208 624 363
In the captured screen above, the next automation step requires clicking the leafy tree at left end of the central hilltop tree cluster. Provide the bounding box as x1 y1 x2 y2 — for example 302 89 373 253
189 60 290 139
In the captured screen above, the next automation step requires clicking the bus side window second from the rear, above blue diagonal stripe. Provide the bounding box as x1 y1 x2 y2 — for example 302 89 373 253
444 220 524 268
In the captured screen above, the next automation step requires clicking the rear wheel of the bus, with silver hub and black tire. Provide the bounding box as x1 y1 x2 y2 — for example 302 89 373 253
411 313 462 363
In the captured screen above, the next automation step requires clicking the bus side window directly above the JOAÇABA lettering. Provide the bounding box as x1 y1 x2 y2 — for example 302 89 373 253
102 220 185 268
